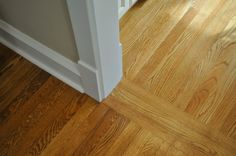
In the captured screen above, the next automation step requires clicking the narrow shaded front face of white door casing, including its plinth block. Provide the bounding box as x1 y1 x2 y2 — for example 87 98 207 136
67 0 103 101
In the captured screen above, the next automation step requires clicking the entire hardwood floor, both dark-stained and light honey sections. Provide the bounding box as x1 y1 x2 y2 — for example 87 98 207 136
0 0 236 156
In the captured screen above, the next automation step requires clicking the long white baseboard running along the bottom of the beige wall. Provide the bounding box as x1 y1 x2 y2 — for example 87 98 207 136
0 20 85 93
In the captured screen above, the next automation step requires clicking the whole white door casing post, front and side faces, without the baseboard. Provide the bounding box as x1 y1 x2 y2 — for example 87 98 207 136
67 0 122 101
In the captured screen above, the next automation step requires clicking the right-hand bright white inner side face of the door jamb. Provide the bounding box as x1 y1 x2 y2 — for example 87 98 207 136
89 0 123 98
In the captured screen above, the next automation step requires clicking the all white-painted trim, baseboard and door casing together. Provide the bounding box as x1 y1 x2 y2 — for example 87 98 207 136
0 0 122 101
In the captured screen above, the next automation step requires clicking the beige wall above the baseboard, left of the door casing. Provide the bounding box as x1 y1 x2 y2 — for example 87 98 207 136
0 0 78 61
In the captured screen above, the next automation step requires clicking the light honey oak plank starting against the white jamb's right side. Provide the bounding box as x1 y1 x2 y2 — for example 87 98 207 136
121 1 191 79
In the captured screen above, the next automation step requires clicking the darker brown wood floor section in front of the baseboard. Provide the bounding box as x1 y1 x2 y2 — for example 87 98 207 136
0 45 128 156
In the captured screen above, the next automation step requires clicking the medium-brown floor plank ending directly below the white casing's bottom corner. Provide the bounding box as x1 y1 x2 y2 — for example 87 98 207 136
41 99 109 156
